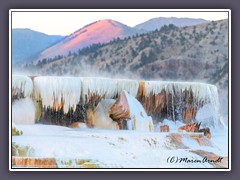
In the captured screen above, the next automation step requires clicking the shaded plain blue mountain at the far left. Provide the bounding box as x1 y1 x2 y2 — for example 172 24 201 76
12 28 63 63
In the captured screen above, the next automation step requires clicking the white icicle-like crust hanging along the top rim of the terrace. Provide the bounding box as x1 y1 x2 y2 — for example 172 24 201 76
12 75 218 106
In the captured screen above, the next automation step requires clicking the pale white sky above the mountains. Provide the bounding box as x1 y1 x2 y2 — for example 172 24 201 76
12 9 228 36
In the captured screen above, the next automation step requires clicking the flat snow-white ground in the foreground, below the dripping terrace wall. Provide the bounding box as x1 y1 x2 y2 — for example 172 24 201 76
12 120 228 168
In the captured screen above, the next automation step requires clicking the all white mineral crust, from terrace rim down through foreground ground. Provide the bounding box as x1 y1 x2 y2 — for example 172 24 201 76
12 75 228 168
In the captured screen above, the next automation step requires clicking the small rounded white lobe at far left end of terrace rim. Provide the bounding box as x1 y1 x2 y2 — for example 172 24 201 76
12 75 33 98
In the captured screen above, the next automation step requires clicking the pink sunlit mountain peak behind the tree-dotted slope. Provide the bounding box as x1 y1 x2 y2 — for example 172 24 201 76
34 19 142 60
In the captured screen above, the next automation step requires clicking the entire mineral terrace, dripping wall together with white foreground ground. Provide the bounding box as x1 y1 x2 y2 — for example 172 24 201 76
12 75 228 168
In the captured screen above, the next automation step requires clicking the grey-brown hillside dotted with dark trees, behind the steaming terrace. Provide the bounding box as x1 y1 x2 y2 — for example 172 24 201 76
24 20 229 117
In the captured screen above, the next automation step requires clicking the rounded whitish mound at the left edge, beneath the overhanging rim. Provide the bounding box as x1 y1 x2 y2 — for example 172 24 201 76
12 98 35 124
